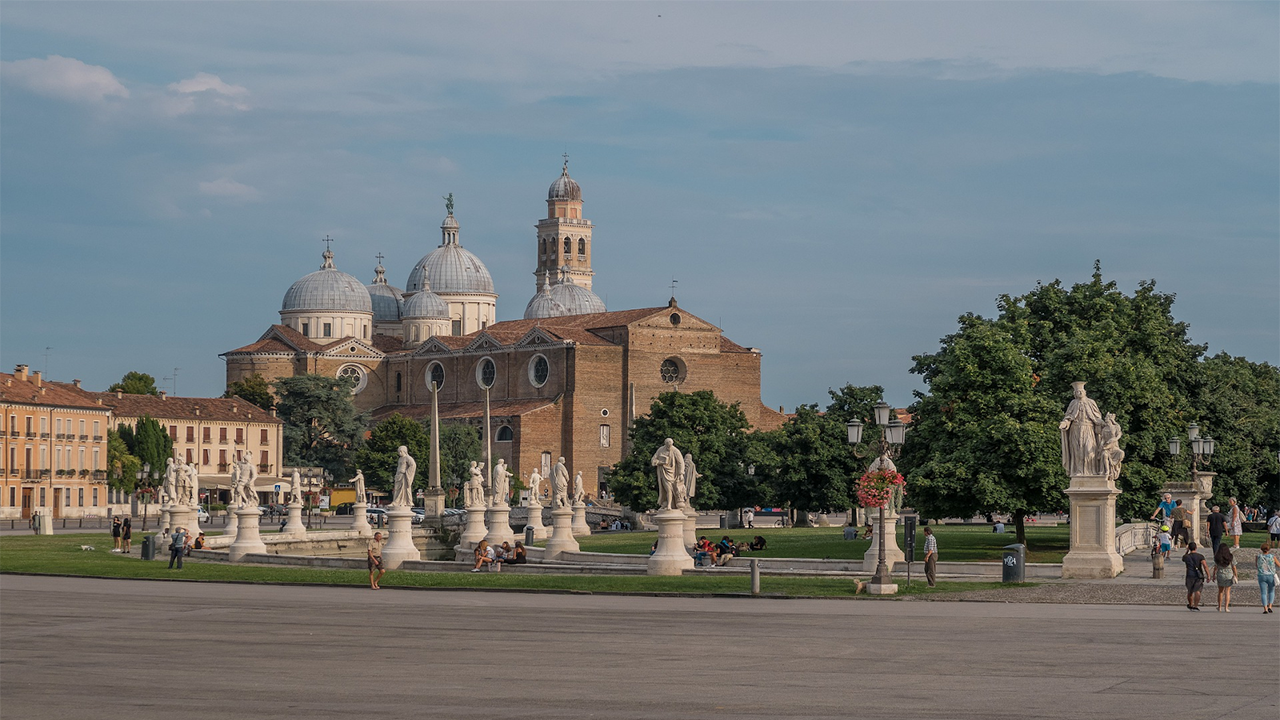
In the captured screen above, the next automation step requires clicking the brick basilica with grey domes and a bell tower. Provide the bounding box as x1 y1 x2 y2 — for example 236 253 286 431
221 161 783 495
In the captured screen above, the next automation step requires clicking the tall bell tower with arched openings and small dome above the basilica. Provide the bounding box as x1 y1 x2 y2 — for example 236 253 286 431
534 155 595 292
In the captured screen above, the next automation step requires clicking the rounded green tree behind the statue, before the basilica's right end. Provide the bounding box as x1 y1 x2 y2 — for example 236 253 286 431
608 389 758 510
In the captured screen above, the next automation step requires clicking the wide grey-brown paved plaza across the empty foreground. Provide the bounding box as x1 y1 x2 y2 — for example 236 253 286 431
0 575 1280 720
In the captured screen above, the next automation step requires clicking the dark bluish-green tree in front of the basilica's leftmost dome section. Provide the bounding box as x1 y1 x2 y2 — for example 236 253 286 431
271 374 369 478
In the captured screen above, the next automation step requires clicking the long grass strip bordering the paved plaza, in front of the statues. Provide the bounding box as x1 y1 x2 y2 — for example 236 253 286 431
0 533 1015 597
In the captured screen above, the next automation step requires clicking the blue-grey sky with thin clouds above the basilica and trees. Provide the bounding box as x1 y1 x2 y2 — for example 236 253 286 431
0 0 1280 410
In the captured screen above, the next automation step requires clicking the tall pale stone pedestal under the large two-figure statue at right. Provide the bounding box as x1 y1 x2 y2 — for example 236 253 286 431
1062 475 1124 578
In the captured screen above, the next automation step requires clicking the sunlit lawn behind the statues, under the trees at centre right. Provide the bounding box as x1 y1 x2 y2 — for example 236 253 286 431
577 525 1070 562
